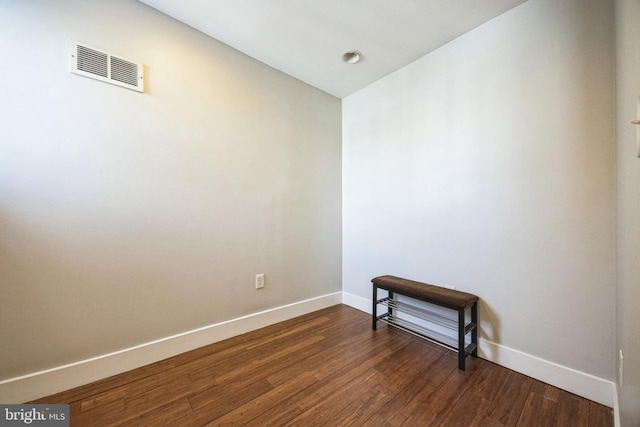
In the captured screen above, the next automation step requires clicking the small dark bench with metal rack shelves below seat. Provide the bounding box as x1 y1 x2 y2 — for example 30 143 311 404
371 276 478 371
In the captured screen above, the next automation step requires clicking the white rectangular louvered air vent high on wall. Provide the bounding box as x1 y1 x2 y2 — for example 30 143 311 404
71 43 144 92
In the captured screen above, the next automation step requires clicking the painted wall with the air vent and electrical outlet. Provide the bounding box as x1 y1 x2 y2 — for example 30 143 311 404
0 0 341 380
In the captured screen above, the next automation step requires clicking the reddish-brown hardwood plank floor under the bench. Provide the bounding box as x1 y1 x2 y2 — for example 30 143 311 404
34 305 613 427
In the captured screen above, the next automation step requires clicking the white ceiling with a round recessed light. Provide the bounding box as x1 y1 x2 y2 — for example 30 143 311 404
140 0 526 98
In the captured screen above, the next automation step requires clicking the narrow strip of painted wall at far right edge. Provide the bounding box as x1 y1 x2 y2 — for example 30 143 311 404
615 0 640 427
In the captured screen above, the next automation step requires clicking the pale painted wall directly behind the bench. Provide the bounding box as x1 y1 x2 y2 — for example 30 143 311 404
343 0 615 380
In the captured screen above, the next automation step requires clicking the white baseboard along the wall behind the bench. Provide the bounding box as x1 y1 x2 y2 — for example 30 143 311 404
342 292 616 409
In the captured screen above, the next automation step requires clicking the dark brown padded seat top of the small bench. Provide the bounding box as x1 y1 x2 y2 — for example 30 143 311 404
371 276 478 308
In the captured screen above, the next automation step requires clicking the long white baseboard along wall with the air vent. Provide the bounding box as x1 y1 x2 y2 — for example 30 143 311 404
0 292 342 404
